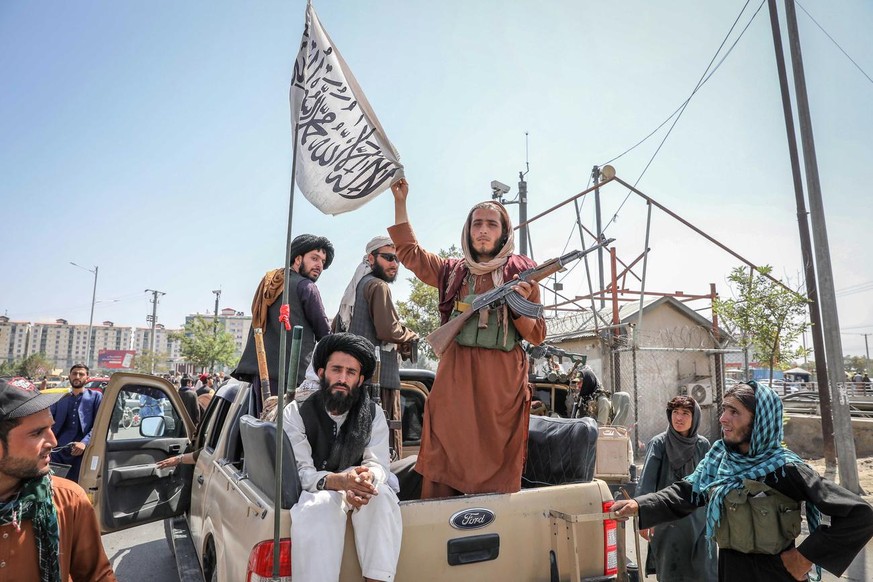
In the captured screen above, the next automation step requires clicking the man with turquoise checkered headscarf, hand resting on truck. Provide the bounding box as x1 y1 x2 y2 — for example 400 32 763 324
613 382 873 582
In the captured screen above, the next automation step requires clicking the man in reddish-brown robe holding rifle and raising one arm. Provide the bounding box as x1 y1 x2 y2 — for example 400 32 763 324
388 179 546 498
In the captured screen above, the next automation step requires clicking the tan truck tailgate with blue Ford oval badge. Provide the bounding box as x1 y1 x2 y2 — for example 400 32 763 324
334 481 611 582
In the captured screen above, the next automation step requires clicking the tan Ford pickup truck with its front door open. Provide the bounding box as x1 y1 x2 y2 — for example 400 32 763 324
79 370 625 582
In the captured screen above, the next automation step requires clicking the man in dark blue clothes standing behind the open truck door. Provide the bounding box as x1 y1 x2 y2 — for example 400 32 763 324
51 364 103 481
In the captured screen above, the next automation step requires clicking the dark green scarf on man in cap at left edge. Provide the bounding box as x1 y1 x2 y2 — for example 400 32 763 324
0 475 61 582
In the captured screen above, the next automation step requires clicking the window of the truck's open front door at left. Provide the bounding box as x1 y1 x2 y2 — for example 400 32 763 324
107 386 185 441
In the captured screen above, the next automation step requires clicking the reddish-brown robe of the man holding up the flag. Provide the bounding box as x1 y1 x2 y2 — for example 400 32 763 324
388 223 546 493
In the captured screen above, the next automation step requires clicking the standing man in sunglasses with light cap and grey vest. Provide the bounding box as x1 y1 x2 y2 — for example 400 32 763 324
332 236 418 459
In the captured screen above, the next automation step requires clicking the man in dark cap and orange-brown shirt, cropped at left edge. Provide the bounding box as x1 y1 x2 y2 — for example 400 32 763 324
0 378 115 582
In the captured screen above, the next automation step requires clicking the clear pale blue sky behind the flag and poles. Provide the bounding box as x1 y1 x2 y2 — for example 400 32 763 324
0 0 873 354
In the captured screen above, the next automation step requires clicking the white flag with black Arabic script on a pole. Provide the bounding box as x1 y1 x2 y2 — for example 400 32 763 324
291 2 403 214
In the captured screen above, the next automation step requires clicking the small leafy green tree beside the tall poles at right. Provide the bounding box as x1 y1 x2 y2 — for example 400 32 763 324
712 265 809 385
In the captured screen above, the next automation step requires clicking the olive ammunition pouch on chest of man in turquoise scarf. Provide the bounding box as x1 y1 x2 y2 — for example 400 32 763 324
715 479 800 555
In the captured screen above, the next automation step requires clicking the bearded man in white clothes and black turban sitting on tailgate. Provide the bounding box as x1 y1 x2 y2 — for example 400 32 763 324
284 333 403 582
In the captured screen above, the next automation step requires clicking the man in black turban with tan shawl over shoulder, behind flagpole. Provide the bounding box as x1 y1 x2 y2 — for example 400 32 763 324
231 234 333 394
